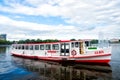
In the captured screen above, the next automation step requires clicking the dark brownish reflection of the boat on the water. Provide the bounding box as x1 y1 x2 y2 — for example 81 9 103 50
12 57 112 80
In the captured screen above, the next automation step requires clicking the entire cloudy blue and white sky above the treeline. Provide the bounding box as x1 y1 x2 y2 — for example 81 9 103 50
0 0 120 40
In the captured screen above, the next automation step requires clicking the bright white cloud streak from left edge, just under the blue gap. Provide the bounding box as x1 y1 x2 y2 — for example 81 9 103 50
0 16 74 31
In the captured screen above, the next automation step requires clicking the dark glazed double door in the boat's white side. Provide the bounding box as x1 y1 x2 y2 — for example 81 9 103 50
60 43 70 56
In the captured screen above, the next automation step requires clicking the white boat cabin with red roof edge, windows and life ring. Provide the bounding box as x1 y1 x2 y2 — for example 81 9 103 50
13 41 85 56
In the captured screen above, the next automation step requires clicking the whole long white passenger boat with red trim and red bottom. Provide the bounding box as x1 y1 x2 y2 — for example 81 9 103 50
11 40 111 63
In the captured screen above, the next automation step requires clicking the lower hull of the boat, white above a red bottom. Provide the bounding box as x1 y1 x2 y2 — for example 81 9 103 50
12 53 111 64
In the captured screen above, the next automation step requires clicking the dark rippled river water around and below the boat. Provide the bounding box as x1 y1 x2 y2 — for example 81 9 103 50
0 44 120 80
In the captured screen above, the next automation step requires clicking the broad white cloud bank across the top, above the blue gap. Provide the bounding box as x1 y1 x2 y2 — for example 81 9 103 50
0 0 120 25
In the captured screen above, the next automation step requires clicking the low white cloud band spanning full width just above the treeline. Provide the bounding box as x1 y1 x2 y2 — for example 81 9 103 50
0 16 120 40
